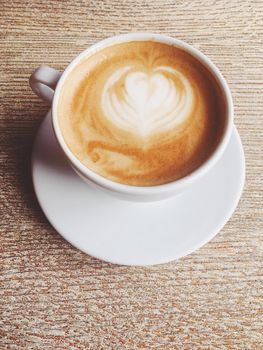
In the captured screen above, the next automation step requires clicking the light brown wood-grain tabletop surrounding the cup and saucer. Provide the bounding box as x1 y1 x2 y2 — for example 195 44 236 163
0 0 263 350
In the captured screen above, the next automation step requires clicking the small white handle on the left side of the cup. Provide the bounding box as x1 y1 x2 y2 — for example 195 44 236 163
29 66 62 104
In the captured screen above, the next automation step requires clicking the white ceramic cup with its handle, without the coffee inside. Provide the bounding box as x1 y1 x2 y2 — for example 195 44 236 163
29 33 233 201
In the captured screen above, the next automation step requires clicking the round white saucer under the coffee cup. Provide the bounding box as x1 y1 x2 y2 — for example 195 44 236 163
32 113 245 265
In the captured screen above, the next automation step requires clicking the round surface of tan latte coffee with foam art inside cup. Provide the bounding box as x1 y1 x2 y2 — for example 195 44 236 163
58 41 225 186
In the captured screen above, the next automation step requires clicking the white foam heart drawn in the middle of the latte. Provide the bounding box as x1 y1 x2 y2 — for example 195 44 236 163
101 66 194 137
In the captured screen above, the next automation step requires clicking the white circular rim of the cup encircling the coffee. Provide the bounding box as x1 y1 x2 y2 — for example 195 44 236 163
51 32 233 195
